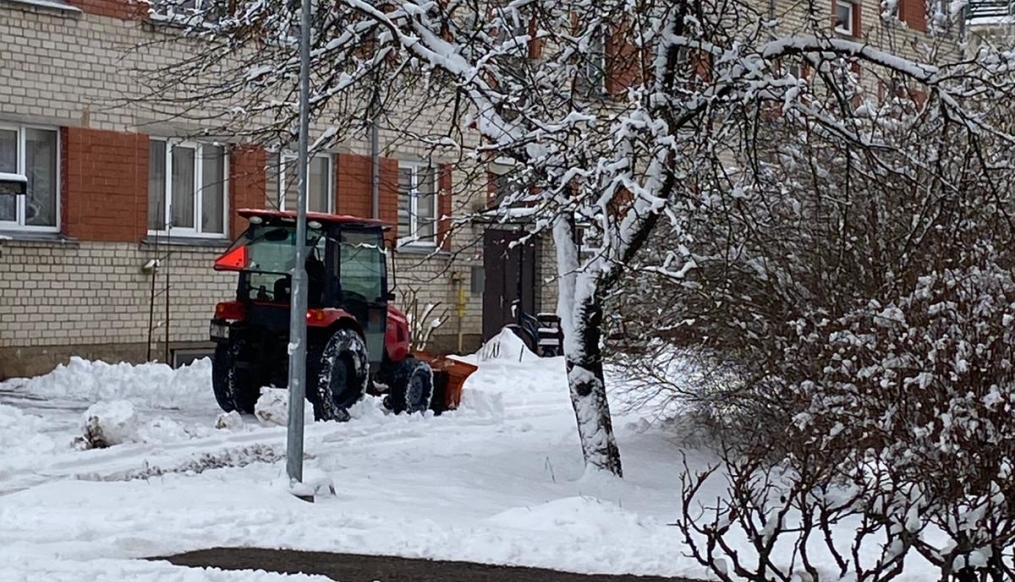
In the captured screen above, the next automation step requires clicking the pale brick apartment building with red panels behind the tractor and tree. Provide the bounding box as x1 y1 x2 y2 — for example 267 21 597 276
0 0 950 379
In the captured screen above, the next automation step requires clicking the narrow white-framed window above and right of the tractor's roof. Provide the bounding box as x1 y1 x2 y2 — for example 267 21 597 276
398 161 437 247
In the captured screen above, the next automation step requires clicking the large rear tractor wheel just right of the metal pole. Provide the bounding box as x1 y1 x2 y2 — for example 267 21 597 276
312 329 369 421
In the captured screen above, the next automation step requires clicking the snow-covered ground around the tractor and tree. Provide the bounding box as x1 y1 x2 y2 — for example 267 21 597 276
0 331 937 582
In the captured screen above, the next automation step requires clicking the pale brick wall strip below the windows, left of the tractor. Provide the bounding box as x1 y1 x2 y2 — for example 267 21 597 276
0 241 235 378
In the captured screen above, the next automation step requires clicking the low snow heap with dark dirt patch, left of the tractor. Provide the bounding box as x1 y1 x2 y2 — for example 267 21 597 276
75 400 210 449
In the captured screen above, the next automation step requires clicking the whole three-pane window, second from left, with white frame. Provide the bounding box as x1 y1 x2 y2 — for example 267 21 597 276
148 139 227 238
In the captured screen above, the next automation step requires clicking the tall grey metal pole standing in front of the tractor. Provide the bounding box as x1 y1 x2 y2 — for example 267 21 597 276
285 0 311 483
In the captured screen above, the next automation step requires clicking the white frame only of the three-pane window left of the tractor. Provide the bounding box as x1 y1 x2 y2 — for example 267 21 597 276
148 137 229 239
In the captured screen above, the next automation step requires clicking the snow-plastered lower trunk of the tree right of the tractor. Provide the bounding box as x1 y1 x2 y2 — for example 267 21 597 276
553 219 623 476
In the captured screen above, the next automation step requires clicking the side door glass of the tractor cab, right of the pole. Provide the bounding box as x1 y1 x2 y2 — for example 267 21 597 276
338 230 386 302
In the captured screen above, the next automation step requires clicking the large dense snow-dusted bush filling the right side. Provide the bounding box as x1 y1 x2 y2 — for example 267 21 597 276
670 77 1015 582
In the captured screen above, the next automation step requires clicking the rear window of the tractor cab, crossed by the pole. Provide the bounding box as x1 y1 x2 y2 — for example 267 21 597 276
233 225 327 306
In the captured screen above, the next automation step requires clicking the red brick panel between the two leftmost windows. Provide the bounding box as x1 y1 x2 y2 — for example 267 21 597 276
61 127 148 242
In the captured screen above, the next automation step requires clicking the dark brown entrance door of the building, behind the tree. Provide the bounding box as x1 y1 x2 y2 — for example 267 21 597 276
483 230 537 341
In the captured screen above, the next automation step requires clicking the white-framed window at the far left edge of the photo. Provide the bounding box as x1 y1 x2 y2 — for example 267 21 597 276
0 124 60 232
